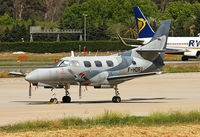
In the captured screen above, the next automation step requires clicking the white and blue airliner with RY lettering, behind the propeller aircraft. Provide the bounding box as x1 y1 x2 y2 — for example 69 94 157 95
134 7 200 61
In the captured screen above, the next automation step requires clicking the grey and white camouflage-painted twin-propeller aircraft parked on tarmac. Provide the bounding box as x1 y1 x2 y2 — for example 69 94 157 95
9 20 171 103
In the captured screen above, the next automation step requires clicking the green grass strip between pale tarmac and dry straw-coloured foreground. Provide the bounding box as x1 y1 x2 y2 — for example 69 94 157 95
0 111 200 132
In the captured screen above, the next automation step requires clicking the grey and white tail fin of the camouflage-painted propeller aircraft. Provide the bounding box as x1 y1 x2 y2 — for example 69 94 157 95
136 20 171 62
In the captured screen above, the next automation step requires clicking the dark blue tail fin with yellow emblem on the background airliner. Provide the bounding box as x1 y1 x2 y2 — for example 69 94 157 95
134 7 154 38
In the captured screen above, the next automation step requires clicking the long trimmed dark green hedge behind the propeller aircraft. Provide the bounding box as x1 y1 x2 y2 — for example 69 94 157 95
0 41 135 53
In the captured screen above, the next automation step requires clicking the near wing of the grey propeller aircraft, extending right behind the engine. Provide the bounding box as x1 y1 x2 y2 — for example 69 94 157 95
107 72 160 84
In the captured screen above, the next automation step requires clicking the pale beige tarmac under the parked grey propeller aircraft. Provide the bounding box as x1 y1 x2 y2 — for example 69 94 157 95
0 72 200 126
